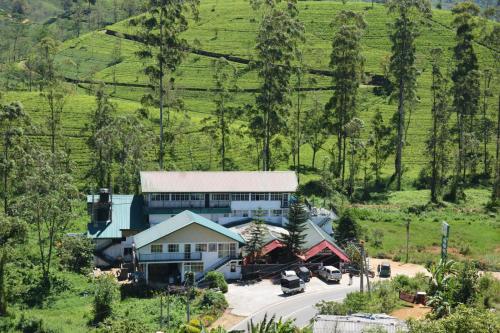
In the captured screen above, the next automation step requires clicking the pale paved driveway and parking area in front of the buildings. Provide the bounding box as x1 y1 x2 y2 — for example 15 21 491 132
226 274 359 330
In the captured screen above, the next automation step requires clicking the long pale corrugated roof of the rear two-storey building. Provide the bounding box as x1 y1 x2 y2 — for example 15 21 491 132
141 171 298 193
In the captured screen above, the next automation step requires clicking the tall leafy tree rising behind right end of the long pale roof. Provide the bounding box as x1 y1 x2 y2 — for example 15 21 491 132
250 0 304 171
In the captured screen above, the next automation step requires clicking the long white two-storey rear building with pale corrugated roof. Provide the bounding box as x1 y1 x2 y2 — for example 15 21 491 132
141 171 298 225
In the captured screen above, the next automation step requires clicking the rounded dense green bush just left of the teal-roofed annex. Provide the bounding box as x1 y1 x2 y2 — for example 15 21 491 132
58 236 94 274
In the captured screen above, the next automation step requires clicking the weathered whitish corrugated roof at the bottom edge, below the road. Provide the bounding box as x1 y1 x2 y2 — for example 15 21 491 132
313 313 408 333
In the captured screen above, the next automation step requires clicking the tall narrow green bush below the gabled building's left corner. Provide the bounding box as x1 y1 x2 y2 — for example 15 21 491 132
92 274 118 324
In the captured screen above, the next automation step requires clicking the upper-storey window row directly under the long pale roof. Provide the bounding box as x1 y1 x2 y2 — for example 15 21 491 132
151 192 288 201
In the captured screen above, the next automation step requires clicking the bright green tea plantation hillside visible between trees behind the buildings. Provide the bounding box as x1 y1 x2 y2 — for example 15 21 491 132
4 0 498 182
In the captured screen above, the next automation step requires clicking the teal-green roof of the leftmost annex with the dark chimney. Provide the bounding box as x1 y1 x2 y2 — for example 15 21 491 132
87 194 148 239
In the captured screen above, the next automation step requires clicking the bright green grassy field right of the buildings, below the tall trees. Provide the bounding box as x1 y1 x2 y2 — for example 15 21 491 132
358 189 500 270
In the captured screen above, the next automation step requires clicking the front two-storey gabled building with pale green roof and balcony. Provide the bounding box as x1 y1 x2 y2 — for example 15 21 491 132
133 210 245 284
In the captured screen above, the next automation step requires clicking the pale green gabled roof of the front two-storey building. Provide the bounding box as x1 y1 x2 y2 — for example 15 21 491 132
134 210 245 249
